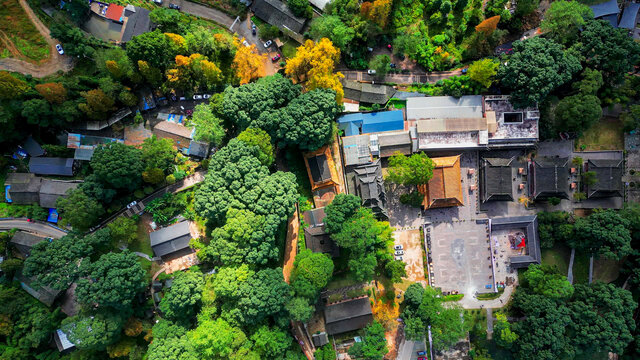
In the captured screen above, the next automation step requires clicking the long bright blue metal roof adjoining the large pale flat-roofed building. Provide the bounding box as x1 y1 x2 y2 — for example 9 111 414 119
338 110 404 136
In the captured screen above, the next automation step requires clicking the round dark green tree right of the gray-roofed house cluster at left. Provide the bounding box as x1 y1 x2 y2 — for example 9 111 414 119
91 142 144 191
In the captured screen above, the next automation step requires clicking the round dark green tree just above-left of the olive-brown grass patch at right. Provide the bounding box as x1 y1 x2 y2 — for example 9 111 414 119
555 94 602 134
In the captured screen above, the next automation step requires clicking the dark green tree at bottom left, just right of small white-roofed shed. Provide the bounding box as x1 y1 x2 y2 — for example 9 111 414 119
61 313 124 350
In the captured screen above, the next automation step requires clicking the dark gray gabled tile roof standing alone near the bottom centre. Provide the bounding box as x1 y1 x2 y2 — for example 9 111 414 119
324 297 373 335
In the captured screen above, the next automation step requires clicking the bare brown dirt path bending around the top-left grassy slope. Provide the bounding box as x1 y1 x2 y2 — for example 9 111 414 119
0 0 73 77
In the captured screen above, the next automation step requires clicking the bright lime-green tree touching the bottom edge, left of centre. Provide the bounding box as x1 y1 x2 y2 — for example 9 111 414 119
189 318 249 360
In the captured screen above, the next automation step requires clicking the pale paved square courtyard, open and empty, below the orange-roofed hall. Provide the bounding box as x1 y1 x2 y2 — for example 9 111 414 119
429 220 493 296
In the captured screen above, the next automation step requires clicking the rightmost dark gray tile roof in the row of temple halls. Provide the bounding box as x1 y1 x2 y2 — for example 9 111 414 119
587 159 624 198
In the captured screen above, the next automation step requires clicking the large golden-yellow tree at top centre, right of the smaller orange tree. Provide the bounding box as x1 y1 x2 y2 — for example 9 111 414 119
285 38 344 104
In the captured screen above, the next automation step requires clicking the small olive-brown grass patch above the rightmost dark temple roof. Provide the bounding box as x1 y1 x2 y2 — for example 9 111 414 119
576 118 624 151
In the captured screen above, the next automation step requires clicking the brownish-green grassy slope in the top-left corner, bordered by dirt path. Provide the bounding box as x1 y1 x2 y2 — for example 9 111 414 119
0 0 50 62
